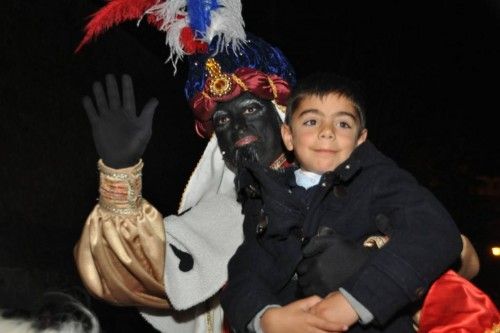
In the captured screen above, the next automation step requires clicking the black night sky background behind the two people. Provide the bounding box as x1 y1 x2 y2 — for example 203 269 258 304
0 0 500 332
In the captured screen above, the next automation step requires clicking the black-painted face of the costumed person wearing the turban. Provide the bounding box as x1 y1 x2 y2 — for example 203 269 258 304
213 92 283 171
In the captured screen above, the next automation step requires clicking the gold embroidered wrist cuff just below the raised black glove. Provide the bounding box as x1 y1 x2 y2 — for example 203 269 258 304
97 160 144 215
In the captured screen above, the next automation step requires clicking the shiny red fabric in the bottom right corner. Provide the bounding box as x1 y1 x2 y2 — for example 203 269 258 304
418 270 500 333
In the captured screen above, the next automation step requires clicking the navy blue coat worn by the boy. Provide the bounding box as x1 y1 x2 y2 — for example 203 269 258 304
221 141 462 333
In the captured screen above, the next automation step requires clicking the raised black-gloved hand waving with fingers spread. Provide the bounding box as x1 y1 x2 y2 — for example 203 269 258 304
82 74 158 169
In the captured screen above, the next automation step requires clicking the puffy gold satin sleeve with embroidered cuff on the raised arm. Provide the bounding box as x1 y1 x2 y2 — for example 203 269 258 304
74 161 170 309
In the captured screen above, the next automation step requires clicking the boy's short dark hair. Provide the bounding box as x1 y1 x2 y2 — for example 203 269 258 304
285 72 366 129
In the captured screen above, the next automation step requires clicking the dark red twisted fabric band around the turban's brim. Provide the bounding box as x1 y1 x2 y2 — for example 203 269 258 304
190 68 290 138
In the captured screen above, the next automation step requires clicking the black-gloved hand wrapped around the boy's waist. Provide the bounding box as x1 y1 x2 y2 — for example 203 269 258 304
297 227 377 297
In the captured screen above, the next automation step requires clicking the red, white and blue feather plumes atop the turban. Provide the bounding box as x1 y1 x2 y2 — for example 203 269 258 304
76 0 245 68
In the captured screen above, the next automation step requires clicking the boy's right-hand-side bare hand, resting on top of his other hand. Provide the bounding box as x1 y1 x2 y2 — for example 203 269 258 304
310 291 359 326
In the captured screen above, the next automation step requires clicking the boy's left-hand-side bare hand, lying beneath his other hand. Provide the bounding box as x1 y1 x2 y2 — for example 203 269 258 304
260 296 348 333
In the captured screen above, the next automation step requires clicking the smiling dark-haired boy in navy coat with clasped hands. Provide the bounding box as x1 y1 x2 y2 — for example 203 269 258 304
222 74 462 333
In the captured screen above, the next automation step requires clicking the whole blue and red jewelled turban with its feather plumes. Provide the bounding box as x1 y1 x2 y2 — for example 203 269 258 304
76 0 295 137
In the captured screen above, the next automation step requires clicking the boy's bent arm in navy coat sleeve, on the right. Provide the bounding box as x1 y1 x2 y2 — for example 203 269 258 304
342 169 462 324
